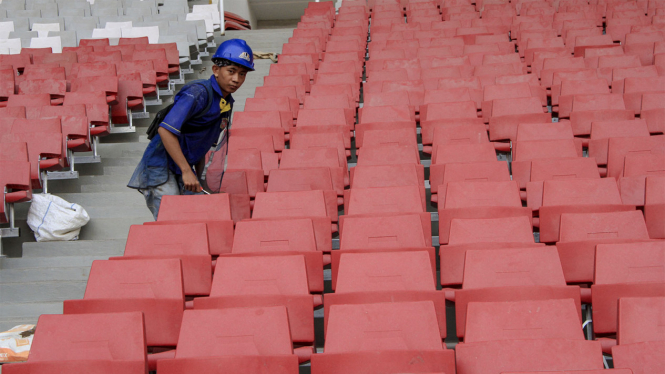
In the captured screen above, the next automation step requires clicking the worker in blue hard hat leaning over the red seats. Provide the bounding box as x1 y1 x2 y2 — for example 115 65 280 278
127 39 254 220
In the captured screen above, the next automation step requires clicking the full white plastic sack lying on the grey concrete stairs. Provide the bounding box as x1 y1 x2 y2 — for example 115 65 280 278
28 194 90 242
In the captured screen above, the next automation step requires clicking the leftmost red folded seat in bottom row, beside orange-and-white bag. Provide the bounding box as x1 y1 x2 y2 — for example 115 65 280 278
2 312 148 374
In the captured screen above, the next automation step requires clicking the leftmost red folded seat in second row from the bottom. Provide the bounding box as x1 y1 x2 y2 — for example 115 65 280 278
63 259 185 346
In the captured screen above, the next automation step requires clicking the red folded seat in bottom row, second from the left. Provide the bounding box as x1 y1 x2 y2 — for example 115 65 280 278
157 306 298 374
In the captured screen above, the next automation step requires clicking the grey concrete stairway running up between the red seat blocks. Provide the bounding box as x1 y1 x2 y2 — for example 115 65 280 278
0 24 295 330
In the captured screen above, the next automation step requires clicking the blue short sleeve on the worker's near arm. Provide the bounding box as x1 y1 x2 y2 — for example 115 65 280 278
159 84 208 136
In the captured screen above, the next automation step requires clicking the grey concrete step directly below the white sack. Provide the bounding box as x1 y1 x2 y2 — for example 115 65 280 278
23 239 126 257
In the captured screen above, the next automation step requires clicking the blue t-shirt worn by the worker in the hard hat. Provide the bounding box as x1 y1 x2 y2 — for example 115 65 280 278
127 75 234 189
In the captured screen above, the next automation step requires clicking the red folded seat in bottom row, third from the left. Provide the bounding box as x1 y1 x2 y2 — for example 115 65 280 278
312 301 455 374
